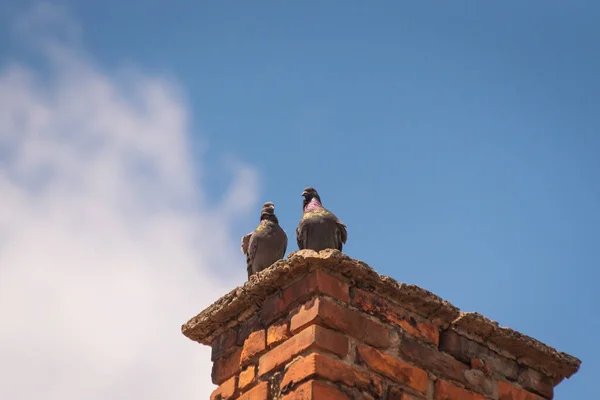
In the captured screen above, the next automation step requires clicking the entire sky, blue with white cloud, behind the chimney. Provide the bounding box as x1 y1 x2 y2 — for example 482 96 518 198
0 0 600 400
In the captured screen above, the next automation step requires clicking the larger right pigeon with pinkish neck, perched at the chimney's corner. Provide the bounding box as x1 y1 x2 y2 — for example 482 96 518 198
296 187 348 251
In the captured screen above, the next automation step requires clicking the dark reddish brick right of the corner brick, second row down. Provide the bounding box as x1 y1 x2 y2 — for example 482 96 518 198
399 337 469 385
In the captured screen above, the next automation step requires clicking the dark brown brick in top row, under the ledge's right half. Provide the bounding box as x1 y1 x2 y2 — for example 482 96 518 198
440 329 519 380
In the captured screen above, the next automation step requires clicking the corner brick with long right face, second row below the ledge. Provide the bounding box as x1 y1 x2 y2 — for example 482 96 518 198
290 297 390 348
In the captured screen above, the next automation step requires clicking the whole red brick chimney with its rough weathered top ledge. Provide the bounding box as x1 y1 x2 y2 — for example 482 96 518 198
182 250 581 400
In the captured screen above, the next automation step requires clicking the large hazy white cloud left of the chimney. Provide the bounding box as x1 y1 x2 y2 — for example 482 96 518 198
0 3 257 400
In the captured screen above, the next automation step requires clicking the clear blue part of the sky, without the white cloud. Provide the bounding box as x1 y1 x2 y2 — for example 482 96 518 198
0 0 600 399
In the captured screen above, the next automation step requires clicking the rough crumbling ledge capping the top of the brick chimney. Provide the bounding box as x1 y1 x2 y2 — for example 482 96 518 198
181 249 581 380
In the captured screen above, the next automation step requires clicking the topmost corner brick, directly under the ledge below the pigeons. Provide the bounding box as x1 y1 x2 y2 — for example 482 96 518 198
260 270 350 324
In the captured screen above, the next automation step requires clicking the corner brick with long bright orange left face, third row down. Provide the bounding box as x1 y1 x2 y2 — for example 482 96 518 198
258 325 348 375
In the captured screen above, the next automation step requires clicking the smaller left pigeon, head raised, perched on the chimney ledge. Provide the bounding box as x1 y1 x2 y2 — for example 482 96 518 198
242 202 287 279
